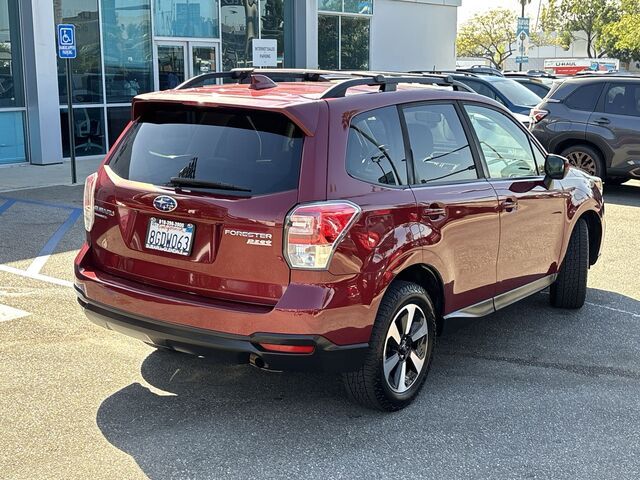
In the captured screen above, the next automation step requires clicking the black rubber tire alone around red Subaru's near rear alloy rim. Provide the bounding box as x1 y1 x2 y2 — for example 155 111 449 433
343 281 436 412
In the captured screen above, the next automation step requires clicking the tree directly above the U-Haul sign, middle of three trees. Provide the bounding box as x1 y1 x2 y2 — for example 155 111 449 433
542 0 620 58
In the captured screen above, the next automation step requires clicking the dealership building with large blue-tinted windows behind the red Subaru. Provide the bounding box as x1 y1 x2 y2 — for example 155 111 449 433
0 0 461 165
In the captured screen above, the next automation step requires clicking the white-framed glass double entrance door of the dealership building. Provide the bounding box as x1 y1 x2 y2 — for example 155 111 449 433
155 41 218 90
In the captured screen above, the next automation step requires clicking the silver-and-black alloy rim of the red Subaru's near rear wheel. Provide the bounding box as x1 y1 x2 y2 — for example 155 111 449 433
383 303 429 393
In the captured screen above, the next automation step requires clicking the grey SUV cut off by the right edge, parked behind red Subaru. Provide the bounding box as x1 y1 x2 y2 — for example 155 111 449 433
531 75 640 183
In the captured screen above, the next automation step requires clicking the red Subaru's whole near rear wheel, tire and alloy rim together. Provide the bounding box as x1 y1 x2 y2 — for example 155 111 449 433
343 281 436 411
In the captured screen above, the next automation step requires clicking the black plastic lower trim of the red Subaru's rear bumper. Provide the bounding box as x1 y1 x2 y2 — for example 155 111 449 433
76 288 369 372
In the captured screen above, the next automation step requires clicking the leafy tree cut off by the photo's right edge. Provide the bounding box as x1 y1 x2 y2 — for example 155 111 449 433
598 0 640 62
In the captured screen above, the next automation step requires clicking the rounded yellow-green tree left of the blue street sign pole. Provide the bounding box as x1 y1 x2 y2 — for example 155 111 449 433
456 8 516 69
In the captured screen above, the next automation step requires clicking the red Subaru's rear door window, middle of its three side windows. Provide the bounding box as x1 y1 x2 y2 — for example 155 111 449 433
402 104 478 184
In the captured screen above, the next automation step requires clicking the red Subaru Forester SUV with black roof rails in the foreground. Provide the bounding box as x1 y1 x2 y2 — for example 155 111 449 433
75 71 604 410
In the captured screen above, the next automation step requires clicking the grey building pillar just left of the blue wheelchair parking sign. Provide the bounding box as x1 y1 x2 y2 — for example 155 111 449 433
22 0 62 165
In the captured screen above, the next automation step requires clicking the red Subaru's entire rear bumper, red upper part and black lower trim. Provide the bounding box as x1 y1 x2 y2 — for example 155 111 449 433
75 245 379 371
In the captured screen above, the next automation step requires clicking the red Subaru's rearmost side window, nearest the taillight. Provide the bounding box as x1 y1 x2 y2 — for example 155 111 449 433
346 107 407 185
